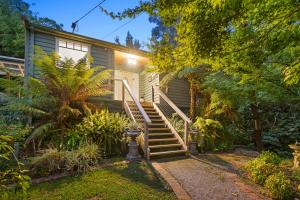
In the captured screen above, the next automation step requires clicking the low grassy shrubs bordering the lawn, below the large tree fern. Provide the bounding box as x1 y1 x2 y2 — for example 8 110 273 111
30 144 98 176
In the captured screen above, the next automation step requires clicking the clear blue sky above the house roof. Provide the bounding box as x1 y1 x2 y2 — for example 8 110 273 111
24 0 155 49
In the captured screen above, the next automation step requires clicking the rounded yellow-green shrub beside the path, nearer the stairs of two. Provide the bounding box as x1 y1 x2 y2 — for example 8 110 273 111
245 151 281 185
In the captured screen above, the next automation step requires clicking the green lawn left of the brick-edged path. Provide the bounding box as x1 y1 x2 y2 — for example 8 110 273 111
12 162 176 200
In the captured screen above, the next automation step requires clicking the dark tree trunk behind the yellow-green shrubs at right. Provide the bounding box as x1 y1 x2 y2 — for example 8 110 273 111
250 103 263 151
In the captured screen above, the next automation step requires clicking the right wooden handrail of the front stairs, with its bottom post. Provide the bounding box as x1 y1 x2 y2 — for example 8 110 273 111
152 85 192 146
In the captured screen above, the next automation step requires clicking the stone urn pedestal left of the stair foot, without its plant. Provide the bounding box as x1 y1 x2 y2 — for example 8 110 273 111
126 130 141 161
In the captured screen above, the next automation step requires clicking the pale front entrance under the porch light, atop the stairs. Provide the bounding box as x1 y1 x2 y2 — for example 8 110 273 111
114 70 140 101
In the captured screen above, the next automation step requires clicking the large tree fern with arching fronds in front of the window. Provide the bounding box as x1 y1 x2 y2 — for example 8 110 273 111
27 49 111 148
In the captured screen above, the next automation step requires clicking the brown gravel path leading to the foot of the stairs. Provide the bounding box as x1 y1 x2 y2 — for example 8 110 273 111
159 158 266 200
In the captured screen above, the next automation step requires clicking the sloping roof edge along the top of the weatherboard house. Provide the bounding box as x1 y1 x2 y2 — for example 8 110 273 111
23 19 149 57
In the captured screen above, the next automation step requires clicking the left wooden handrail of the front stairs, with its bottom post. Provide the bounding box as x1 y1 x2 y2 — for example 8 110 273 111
121 80 152 160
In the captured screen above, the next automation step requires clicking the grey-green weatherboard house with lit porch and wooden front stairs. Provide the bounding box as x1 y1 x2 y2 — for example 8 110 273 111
24 21 190 158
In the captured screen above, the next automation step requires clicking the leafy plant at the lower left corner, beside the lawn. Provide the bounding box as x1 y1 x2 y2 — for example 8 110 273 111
0 135 30 199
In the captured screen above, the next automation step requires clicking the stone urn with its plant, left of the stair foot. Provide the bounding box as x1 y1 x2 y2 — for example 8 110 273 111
125 121 141 161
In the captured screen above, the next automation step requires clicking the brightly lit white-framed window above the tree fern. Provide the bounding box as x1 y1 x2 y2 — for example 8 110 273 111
58 39 89 62
